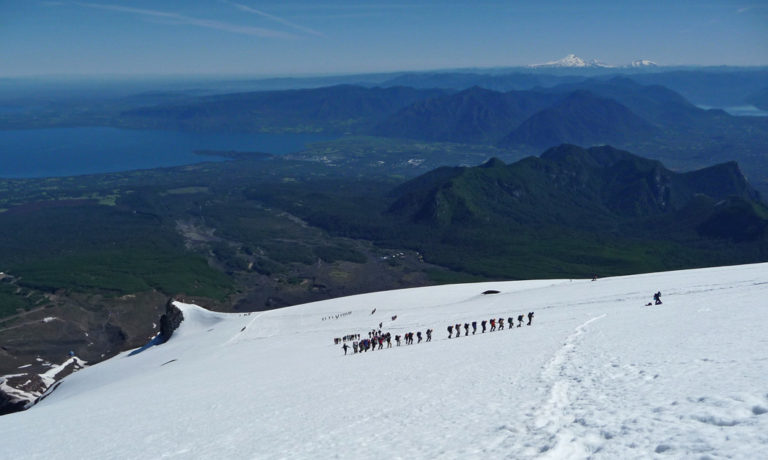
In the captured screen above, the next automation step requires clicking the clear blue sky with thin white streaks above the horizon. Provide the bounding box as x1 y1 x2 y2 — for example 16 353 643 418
0 0 768 76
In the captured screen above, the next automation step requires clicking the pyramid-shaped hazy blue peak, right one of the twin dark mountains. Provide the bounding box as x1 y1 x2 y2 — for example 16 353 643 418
501 91 658 148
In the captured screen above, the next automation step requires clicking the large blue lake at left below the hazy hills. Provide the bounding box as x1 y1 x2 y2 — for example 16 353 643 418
0 127 338 178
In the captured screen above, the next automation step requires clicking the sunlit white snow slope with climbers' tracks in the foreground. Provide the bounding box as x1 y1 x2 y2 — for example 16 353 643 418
0 264 768 459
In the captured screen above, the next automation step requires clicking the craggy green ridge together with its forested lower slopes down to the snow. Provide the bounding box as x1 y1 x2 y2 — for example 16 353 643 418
243 145 768 278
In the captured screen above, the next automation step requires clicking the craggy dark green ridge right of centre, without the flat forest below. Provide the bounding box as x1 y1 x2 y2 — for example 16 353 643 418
389 145 768 235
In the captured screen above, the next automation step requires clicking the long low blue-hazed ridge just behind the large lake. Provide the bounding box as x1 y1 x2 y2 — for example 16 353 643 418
116 85 445 133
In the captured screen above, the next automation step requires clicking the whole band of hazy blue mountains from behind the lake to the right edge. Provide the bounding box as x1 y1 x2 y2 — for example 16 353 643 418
90 75 768 184
